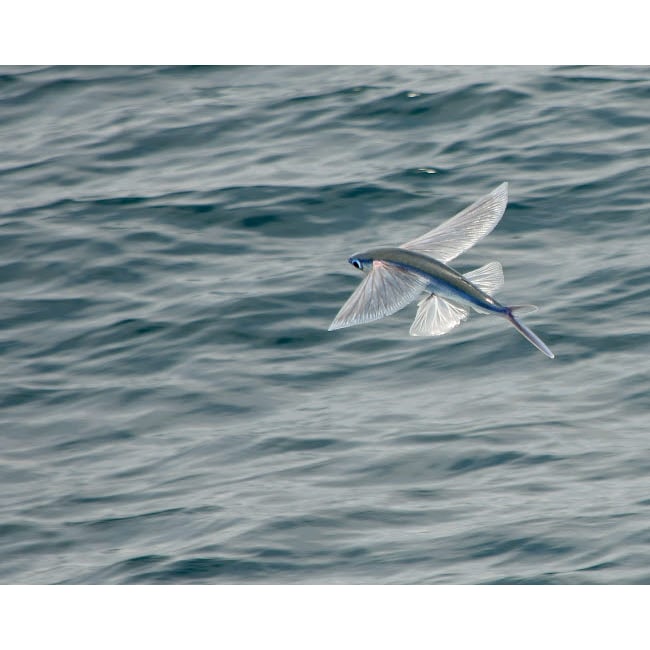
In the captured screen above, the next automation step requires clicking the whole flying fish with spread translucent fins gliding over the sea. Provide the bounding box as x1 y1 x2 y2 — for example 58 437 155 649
329 183 555 358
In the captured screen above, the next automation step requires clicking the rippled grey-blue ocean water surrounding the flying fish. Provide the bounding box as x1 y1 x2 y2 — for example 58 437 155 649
0 67 650 584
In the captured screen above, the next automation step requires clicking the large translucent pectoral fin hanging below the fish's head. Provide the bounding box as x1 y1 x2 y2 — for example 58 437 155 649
329 260 426 331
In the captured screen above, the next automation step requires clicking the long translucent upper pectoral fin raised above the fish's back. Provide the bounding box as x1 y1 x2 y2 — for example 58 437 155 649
401 183 508 262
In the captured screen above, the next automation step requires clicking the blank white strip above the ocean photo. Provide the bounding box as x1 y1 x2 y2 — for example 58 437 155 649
0 0 648 65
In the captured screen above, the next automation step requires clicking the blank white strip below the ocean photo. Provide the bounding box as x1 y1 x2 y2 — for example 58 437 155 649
0 586 648 650
